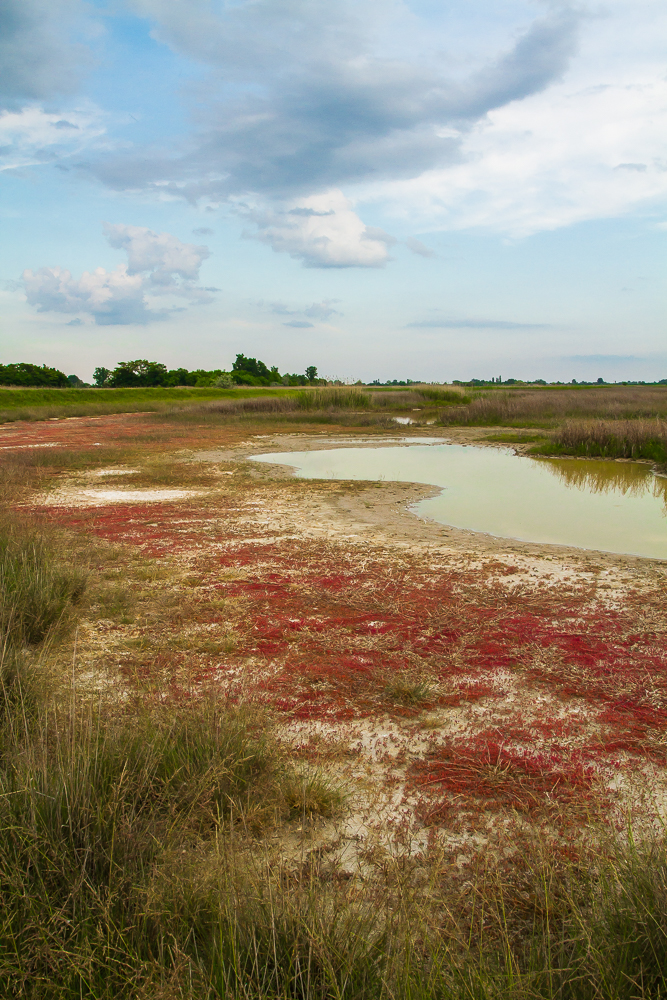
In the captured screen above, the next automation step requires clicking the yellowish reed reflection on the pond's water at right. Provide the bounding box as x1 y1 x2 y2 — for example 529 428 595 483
533 458 667 516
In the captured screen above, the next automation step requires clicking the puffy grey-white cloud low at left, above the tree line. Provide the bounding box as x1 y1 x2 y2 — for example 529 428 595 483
23 223 211 326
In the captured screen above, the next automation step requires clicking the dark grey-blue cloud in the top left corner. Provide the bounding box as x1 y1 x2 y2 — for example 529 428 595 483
0 0 90 110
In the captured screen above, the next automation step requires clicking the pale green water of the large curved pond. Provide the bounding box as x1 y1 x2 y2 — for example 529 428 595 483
252 444 667 559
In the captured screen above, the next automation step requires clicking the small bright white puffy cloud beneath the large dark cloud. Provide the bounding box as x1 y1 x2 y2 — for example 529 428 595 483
241 190 396 267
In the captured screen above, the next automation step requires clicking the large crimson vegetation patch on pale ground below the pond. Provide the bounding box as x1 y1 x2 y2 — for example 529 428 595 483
19 442 667 828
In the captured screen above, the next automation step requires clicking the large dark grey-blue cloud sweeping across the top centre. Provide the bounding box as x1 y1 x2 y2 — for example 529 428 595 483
95 0 578 207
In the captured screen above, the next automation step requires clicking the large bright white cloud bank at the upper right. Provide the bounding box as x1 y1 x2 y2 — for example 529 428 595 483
356 0 667 237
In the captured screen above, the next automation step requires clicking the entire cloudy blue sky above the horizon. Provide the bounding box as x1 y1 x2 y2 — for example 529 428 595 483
0 0 667 382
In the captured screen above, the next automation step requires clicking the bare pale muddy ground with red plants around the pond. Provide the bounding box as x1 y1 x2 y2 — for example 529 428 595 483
5 414 667 870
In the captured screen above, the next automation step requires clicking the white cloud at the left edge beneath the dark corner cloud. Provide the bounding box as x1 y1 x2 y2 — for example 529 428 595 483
0 106 105 170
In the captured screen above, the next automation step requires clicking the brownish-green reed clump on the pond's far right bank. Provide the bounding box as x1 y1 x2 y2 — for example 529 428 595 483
540 420 667 463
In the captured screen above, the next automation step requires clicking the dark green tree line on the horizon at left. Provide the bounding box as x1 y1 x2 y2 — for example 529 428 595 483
0 354 326 389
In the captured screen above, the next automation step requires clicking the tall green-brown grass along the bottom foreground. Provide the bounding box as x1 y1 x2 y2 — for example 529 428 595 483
0 688 667 1000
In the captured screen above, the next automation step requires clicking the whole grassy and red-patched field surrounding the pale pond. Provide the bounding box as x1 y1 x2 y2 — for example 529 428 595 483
0 387 667 1000
